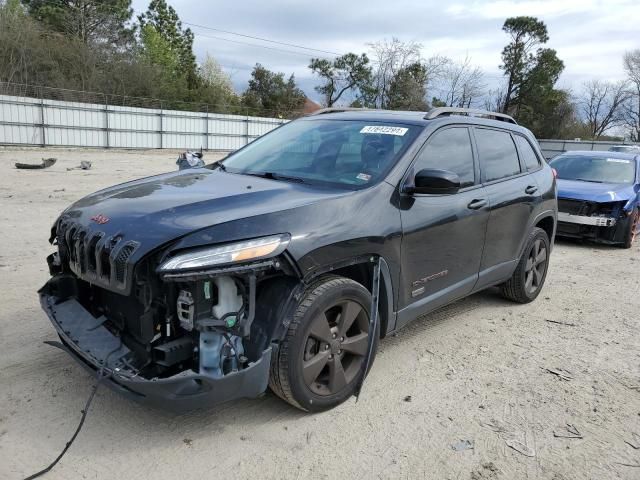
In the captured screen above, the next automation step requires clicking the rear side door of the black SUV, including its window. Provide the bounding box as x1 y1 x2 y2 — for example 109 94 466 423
473 126 539 288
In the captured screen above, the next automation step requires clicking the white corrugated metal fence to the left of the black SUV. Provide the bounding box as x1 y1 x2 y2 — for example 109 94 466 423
0 90 287 151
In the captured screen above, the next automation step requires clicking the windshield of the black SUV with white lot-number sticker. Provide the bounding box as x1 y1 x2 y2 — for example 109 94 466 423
222 119 421 188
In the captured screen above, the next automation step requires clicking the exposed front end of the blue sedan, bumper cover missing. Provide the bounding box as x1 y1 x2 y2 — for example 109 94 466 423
557 198 632 244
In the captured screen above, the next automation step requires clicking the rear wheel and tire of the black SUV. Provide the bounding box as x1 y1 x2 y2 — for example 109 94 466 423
501 227 550 303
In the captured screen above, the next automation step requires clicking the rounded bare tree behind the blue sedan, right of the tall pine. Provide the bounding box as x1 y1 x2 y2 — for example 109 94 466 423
578 80 629 139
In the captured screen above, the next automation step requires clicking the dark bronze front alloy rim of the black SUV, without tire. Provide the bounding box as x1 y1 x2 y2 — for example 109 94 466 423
302 300 369 396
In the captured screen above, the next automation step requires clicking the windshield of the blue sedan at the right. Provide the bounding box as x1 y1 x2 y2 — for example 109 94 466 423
551 155 636 183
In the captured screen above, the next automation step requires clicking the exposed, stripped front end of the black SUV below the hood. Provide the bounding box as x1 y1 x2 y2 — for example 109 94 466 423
39 219 301 411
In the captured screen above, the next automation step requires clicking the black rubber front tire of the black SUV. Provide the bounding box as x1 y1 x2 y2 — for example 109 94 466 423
269 276 380 412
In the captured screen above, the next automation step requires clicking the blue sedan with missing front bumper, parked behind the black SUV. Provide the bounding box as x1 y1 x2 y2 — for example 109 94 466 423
551 152 640 248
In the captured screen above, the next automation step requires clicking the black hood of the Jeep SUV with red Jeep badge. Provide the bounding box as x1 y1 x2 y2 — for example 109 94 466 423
57 168 354 258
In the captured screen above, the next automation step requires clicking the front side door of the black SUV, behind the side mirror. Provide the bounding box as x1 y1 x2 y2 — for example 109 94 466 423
398 126 489 327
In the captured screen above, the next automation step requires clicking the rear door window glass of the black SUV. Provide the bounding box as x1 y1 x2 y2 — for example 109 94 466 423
475 128 520 182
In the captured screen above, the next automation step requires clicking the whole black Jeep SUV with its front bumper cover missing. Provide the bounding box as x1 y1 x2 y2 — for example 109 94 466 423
40 108 557 411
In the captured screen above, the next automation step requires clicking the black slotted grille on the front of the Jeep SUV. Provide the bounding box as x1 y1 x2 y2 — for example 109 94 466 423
56 222 139 290
